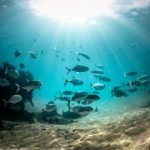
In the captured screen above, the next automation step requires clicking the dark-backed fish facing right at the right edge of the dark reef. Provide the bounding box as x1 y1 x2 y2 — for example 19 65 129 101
21 80 42 92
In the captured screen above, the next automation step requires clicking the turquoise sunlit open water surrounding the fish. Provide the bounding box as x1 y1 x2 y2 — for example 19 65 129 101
0 1 150 115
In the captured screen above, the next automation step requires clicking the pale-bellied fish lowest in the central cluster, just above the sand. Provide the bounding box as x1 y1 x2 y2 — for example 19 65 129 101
72 106 93 117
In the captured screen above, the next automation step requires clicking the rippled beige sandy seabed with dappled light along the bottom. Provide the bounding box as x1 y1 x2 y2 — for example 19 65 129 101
0 108 150 150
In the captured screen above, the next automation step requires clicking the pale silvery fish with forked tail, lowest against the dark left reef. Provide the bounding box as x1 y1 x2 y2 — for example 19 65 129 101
3 94 22 108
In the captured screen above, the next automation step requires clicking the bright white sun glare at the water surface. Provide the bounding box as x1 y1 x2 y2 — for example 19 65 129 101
29 0 114 23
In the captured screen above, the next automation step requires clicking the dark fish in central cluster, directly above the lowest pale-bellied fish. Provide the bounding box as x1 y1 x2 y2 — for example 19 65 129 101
72 91 88 103
